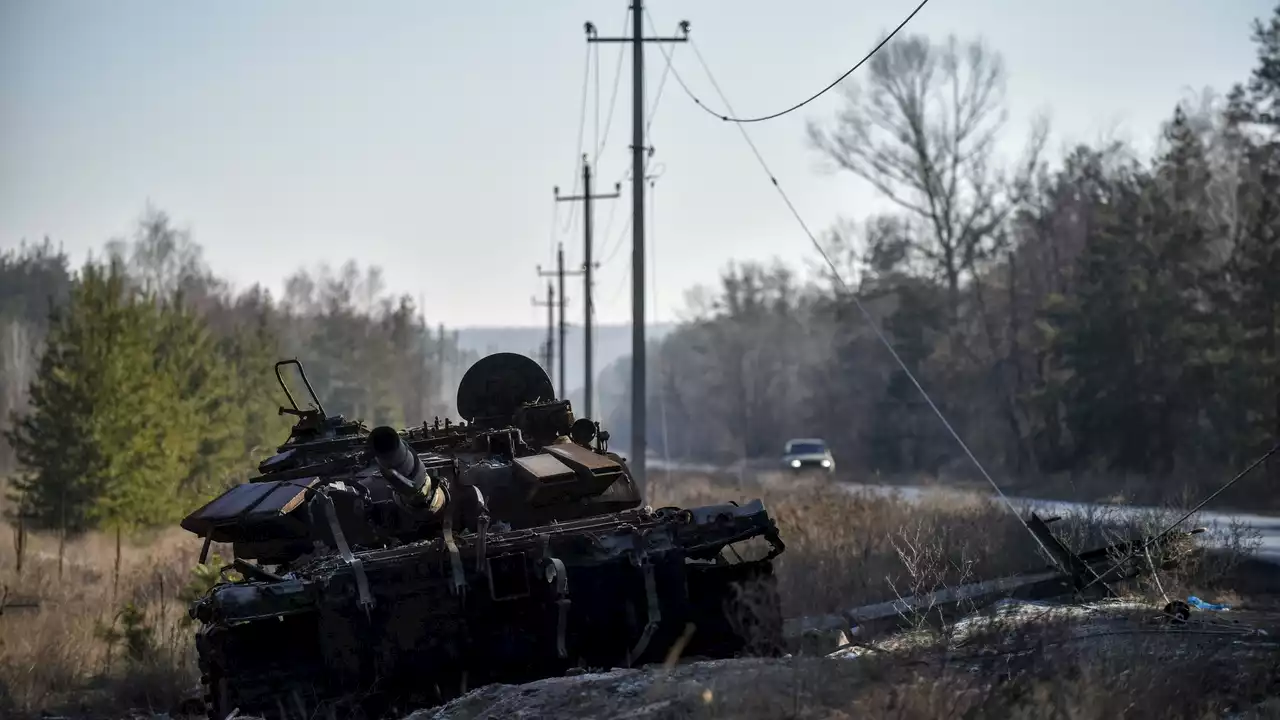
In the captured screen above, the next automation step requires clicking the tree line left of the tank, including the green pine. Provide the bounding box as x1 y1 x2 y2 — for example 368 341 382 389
0 209 474 533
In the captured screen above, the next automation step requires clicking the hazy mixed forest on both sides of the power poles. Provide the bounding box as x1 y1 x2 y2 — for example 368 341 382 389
0 6 1280 532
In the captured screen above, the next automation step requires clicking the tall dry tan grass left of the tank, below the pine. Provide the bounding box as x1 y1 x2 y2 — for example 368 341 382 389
0 515 212 717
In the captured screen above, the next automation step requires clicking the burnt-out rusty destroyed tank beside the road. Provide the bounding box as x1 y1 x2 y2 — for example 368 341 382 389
182 354 783 720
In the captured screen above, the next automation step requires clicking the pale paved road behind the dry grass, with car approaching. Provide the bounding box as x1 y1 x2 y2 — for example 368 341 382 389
648 459 1280 565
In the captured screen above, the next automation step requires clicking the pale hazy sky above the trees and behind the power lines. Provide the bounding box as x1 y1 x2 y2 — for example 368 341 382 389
0 0 1274 327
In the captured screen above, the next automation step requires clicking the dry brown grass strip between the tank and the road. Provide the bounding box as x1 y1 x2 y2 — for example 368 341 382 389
650 473 1256 616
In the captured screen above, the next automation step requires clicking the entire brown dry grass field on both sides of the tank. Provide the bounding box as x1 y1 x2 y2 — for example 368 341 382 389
0 473 1280 719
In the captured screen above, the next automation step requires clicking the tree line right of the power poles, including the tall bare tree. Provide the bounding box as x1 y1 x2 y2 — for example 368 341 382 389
607 6 1280 502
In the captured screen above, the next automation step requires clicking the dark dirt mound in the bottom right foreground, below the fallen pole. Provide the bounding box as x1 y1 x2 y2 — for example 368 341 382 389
408 591 1280 720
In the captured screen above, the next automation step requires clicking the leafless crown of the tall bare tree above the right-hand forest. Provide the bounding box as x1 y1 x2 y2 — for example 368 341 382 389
808 36 1044 307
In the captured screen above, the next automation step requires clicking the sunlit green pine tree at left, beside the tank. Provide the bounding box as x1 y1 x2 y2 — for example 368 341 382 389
9 254 252 532
